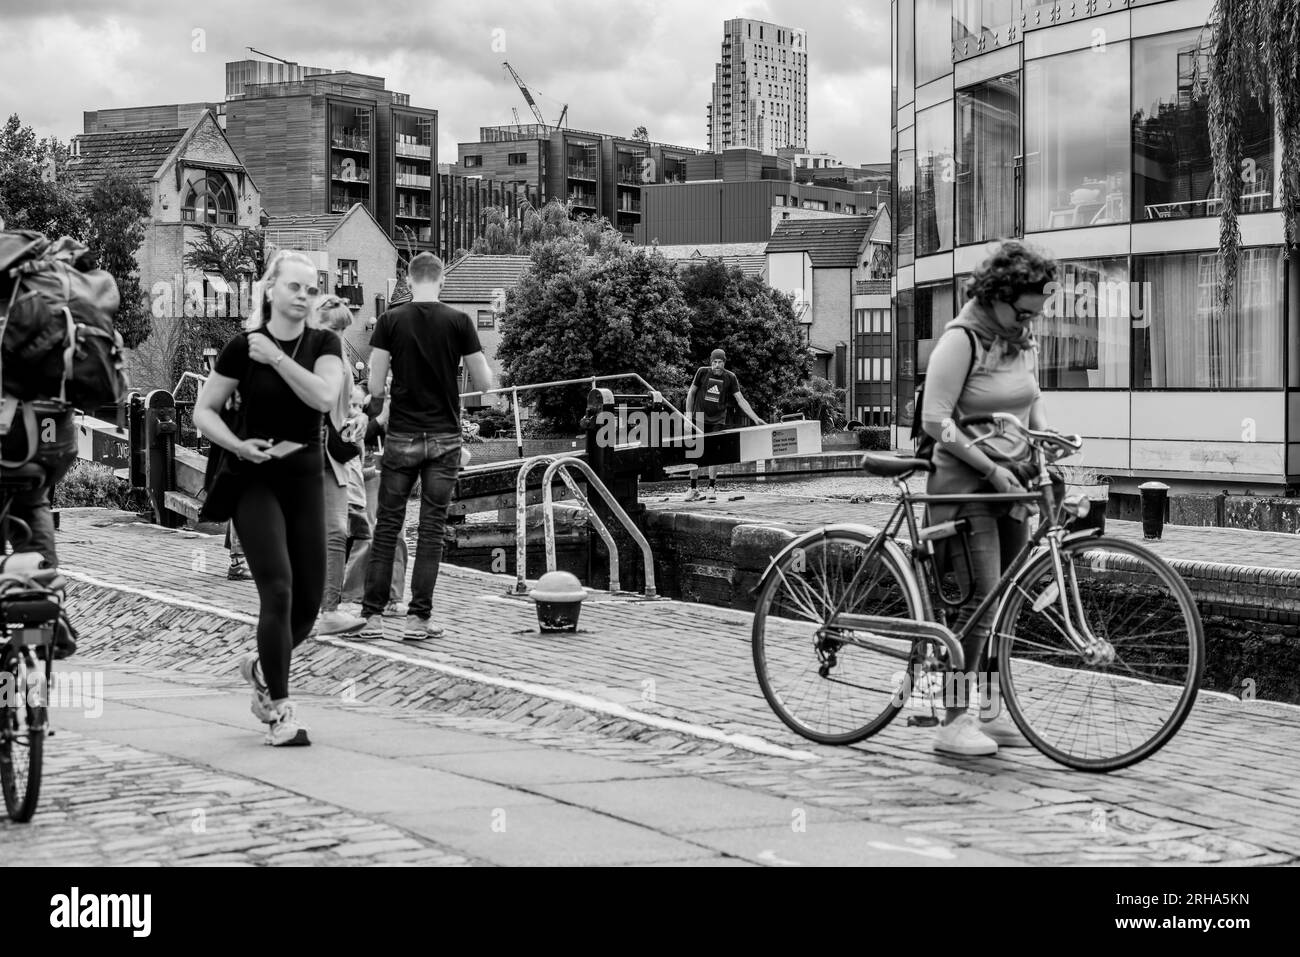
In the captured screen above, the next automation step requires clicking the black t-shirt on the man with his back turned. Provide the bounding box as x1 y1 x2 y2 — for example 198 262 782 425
371 303 484 434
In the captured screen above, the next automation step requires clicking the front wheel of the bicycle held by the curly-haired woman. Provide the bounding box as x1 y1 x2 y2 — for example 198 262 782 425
993 538 1205 771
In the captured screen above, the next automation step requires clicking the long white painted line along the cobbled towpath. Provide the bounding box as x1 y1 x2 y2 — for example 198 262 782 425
60 567 820 762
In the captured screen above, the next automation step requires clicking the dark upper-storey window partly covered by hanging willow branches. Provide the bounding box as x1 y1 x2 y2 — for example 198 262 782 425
1132 30 1275 220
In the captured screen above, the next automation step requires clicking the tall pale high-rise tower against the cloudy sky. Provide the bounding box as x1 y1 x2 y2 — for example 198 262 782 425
706 20 809 153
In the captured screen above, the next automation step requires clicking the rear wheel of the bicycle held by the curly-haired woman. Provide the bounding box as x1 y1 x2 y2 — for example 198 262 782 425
753 531 922 744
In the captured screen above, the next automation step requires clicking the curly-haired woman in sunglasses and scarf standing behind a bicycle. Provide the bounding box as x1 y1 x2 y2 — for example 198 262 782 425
919 241 1056 755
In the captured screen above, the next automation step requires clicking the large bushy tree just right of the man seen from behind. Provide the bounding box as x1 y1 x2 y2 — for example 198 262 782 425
497 230 693 432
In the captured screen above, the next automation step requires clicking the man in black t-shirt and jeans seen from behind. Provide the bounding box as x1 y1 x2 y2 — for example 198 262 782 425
358 252 493 641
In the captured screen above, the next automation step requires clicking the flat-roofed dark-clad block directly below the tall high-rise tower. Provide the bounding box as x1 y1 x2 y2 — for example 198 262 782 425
633 147 876 246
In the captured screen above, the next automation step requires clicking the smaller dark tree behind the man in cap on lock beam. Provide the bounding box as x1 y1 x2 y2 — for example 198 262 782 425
680 259 811 417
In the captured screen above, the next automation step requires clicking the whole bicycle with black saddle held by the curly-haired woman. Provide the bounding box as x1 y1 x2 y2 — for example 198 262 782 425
753 413 1205 771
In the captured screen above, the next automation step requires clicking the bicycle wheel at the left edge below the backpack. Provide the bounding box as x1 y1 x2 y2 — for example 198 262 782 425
0 645 48 823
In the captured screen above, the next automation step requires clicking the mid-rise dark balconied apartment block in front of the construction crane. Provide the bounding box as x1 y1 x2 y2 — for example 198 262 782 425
458 124 699 239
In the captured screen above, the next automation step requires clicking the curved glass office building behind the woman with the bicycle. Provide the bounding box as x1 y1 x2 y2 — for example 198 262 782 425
892 0 1300 493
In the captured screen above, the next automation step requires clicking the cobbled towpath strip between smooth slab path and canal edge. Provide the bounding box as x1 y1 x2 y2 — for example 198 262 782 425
38 512 1300 865
